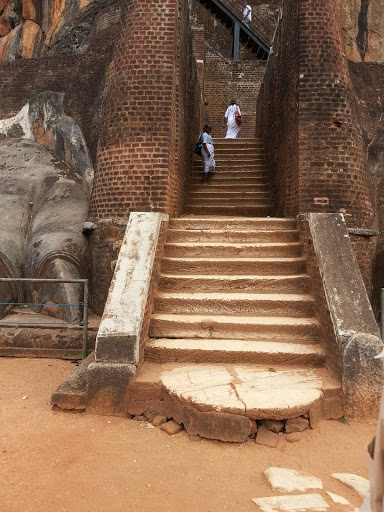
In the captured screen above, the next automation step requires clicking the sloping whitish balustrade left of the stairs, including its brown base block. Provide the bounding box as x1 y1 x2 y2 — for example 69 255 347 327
87 213 168 415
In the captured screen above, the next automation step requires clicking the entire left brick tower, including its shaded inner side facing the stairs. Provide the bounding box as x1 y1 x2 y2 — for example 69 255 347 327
89 0 201 311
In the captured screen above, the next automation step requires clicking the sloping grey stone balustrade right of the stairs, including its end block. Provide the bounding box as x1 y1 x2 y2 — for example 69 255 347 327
305 213 383 417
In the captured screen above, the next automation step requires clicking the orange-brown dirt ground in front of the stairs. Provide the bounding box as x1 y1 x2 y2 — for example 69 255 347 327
0 358 376 512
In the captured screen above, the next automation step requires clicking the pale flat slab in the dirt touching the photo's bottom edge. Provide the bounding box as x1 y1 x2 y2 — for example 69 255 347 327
252 494 329 512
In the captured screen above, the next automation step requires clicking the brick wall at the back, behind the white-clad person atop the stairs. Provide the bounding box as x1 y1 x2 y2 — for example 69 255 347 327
204 47 266 138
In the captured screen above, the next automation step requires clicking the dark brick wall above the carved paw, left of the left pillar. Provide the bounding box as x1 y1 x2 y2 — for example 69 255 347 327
0 32 114 162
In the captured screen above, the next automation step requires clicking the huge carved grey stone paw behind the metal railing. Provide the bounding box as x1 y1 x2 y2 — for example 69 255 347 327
0 139 89 322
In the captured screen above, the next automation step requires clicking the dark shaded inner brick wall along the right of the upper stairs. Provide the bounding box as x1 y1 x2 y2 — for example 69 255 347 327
256 0 299 217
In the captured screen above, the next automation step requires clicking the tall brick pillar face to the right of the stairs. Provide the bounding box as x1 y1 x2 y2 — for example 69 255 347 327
299 0 374 227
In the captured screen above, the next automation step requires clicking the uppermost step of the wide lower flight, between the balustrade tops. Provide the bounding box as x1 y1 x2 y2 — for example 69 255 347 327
169 215 296 231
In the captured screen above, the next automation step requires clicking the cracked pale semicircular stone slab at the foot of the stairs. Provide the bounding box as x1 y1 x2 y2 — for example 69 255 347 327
160 365 323 419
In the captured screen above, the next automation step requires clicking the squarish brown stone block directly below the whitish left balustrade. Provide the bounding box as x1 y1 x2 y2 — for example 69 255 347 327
86 362 136 416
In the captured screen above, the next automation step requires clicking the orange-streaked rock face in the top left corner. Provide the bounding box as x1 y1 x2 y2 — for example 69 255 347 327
0 0 120 62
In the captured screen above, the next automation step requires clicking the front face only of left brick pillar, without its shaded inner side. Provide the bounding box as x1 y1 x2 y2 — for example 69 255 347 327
89 0 177 221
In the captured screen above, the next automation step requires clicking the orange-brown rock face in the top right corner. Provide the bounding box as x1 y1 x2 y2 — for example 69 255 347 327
338 0 384 62
